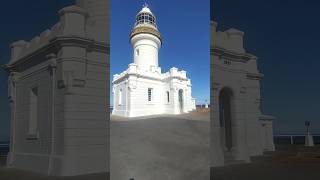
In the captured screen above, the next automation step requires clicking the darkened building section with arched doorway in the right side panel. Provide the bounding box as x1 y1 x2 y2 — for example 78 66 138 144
210 22 274 167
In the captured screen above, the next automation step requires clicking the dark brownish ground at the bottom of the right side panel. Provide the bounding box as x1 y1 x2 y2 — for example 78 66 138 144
211 145 320 180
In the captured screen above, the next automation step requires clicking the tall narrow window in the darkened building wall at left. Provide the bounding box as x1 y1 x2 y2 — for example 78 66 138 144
28 87 38 135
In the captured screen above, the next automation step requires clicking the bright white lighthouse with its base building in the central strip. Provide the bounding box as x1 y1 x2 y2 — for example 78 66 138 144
112 6 195 117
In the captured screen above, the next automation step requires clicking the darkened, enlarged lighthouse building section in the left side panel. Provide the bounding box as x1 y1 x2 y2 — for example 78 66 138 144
5 0 109 176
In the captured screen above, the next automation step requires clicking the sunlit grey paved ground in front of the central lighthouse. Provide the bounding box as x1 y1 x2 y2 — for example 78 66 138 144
110 112 209 180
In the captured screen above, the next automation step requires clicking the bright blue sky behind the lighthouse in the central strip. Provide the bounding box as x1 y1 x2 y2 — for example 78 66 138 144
110 0 210 103
